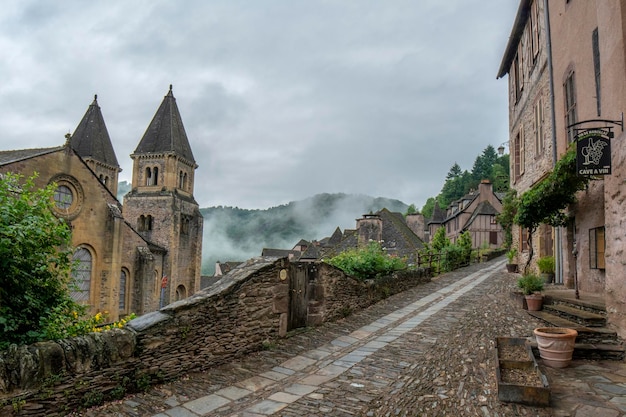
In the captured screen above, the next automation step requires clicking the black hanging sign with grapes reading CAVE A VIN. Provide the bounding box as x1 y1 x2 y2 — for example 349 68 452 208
576 129 611 176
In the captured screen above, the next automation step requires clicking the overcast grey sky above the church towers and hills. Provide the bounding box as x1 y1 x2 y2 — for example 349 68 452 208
0 0 519 209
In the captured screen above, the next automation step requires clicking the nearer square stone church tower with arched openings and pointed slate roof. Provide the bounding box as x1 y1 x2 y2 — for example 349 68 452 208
124 85 203 305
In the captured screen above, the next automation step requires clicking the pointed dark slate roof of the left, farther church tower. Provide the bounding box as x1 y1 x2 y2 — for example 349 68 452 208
70 95 120 168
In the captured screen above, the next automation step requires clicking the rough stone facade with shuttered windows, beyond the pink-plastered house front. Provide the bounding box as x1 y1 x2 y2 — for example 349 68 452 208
498 0 557 272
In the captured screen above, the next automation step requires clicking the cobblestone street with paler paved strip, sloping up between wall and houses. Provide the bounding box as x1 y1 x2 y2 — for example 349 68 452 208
76 259 626 417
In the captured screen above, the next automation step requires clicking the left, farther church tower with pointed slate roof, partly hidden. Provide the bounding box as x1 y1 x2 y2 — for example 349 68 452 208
69 95 122 195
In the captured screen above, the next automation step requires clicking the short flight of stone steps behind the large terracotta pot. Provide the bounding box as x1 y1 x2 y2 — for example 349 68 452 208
528 290 626 360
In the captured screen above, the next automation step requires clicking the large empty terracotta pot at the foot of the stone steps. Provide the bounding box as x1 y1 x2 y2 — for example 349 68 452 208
534 327 578 368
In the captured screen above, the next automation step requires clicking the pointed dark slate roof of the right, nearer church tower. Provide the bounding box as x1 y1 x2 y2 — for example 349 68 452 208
133 85 196 164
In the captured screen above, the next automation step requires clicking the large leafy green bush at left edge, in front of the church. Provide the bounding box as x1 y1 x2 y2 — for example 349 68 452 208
0 173 73 348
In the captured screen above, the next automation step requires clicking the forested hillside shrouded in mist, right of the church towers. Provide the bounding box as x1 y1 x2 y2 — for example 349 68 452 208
200 194 408 275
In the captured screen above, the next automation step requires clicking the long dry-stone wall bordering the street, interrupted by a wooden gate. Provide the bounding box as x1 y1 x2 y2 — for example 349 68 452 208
0 257 430 416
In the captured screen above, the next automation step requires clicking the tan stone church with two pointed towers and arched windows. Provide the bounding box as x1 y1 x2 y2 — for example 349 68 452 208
0 86 203 321
